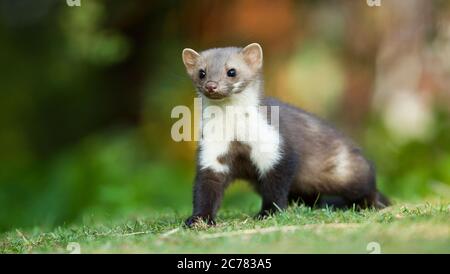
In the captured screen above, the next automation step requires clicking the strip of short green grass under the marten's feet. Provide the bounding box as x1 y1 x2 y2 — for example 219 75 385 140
0 202 450 253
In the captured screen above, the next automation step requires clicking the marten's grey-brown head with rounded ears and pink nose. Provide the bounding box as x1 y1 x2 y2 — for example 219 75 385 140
183 43 263 100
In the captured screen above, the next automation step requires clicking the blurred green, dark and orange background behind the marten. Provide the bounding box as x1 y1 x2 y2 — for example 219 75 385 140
0 0 450 230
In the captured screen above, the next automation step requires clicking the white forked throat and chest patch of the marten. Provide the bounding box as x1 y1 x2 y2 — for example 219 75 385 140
199 84 282 176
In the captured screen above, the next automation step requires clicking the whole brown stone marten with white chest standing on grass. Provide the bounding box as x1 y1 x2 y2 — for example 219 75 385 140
182 43 389 226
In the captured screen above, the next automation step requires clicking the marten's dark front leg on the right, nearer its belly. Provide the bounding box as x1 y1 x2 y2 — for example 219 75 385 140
256 153 298 219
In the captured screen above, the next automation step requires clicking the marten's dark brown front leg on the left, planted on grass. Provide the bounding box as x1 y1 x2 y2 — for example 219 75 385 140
185 169 229 227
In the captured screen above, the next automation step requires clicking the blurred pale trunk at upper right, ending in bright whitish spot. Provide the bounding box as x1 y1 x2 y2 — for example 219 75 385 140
374 0 433 140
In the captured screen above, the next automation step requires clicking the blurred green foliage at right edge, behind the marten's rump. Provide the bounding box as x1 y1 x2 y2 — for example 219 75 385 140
365 110 450 200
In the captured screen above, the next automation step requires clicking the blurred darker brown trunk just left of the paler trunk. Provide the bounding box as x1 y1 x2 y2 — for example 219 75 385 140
339 1 381 131
